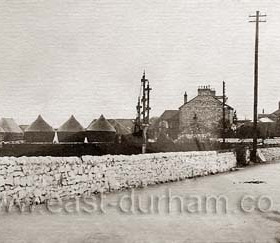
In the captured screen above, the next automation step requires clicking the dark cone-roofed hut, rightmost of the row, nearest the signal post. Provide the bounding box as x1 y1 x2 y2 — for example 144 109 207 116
86 115 116 143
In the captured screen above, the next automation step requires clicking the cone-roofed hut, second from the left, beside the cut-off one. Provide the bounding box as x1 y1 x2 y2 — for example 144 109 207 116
24 115 55 143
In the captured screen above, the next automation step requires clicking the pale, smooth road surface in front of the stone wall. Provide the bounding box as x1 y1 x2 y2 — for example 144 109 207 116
0 163 280 243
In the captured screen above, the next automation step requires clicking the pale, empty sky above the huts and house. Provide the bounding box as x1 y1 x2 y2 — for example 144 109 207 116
0 0 280 127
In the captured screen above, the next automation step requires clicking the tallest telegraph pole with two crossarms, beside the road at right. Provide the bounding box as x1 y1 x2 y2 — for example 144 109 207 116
249 11 266 162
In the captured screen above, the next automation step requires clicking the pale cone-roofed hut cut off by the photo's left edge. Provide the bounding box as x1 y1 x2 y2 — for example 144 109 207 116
0 118 23 141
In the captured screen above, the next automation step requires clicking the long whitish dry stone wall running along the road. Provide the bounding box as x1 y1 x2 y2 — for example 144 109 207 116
0 151 236 204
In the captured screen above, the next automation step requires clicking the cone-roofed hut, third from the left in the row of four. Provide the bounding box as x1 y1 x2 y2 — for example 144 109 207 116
57 115 85 143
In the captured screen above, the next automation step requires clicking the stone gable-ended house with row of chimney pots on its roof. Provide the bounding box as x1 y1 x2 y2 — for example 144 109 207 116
179 86 234 135
